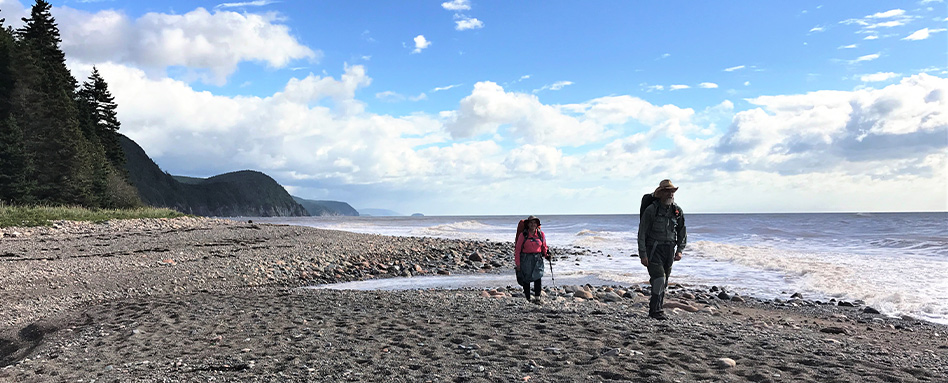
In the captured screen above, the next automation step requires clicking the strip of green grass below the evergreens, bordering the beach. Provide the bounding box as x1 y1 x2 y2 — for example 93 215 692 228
0 203 185 227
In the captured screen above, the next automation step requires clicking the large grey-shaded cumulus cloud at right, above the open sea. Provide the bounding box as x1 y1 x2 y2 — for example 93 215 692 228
716 74 948 177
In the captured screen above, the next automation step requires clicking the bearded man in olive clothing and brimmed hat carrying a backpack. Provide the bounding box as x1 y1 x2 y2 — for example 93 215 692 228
638 180 688 320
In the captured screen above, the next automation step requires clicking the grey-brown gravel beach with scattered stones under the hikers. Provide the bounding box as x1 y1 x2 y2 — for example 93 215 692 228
0 218 948 382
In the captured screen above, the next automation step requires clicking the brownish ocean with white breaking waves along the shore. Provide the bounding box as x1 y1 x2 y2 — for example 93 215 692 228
251 212 948 324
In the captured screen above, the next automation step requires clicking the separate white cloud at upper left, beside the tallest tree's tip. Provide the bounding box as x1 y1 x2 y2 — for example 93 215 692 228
53 7 321 85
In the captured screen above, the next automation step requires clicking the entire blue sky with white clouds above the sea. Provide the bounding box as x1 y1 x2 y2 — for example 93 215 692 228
0 0 948 215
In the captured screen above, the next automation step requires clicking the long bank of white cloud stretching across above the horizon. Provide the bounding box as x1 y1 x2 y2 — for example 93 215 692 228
73 60 948 214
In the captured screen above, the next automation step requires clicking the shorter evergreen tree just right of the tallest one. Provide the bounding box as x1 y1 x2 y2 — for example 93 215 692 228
79 67 125 173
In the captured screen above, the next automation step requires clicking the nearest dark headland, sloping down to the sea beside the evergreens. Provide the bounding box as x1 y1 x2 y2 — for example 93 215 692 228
119 135 310 217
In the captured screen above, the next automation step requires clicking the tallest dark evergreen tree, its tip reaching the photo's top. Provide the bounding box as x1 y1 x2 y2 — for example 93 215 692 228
13 0 98 206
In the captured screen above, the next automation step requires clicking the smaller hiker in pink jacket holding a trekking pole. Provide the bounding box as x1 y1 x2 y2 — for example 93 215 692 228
514 215 552 304
